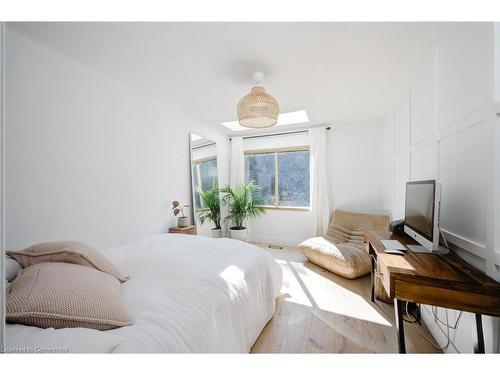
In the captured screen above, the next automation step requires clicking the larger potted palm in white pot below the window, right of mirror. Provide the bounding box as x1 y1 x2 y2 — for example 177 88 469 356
221 181 266 242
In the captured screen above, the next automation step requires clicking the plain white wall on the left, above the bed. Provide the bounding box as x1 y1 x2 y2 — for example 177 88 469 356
6 30 226 249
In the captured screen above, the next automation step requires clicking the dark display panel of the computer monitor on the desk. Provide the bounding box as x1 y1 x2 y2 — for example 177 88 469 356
405 180 436 241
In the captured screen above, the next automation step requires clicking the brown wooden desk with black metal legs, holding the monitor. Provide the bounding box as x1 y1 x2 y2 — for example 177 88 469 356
366 231 500 353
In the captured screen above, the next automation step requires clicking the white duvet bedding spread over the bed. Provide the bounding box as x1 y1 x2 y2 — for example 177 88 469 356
6 234 282 353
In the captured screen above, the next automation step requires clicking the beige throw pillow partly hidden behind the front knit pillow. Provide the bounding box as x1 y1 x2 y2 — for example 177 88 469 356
7 241 128 282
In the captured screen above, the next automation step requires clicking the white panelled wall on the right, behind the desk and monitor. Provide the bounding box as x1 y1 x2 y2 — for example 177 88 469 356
383 23 500 352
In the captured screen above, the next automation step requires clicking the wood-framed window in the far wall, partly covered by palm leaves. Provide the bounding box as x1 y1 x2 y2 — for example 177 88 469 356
245 147 310 207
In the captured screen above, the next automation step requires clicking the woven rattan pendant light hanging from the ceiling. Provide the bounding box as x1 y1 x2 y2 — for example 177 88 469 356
237 72 280 128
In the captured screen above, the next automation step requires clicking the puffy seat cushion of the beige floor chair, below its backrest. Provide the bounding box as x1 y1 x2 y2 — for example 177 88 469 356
299 237 371 279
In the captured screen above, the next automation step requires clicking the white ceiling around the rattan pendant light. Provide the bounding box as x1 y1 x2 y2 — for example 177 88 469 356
8 23 446 134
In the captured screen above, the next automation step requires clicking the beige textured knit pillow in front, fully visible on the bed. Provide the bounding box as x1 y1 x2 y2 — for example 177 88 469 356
6 262 132 331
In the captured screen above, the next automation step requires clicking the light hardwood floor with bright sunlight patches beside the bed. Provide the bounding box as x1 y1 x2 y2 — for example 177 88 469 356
252 244 439 353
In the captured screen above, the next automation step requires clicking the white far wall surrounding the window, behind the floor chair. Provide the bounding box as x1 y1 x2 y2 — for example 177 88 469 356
244 120 383 246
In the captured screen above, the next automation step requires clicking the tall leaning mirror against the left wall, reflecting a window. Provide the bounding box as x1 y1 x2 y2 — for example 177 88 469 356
190 133 222 238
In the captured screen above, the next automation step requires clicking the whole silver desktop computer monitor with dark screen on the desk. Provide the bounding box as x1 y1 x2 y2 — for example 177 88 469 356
404 180 441 251
